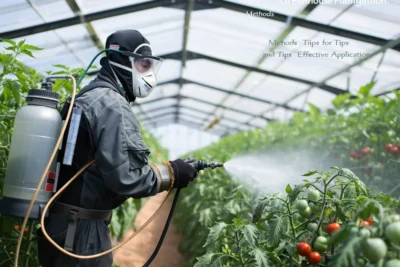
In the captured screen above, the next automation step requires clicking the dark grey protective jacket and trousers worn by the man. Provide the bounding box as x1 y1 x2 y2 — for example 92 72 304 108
38 71 159 267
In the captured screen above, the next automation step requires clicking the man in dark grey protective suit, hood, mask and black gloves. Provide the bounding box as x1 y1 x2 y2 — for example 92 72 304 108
38 30 198 267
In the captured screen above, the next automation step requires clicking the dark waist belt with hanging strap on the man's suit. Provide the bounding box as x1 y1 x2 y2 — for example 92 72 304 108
50 202 112 252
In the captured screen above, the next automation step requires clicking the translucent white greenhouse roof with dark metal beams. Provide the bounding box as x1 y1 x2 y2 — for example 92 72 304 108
0 0 400 138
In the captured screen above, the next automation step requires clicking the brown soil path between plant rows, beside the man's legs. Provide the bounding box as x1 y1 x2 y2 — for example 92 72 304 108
114 193 185 267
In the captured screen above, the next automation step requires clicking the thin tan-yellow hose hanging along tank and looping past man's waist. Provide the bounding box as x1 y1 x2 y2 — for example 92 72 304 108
14 75 172 267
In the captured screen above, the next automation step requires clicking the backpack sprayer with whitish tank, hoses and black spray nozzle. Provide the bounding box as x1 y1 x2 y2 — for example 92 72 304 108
0 49 223 267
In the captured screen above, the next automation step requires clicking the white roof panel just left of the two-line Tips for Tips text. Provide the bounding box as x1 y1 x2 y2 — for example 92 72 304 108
188 9 285 65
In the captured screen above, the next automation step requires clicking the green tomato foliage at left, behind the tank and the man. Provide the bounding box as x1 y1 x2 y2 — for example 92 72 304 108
0 39 168 267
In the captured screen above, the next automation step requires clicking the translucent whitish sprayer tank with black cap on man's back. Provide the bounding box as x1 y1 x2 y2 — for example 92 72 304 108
3 89 62 216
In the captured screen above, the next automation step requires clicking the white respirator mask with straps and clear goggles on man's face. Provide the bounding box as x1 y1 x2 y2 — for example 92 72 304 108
109 43 163 98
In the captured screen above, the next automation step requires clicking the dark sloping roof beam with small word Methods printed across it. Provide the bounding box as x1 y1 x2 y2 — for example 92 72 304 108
212 0 400 52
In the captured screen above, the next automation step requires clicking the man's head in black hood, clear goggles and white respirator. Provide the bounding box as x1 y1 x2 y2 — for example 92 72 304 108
106 30 162 101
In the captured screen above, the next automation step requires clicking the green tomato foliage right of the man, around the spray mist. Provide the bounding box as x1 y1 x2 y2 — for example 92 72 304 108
176 83 400 266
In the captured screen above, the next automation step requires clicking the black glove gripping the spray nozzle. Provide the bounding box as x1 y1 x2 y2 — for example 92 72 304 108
170 159 199 188
